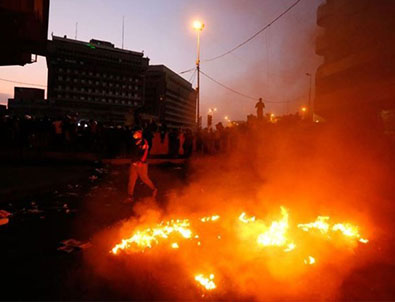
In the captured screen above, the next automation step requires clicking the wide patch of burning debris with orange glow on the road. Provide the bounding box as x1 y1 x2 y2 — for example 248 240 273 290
110 207 368 291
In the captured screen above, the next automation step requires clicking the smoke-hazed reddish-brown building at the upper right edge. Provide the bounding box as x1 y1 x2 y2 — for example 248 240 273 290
314 0 395 126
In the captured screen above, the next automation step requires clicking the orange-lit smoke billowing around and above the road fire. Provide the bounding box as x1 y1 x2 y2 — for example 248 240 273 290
87 119 394 300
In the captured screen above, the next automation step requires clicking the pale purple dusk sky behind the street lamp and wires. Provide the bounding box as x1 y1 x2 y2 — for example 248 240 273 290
0 0 322 122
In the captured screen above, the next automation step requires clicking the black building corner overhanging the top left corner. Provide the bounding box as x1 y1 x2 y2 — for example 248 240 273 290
0 0 49 65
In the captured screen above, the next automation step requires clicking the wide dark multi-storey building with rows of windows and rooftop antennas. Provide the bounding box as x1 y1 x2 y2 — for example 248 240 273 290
47 36 149 123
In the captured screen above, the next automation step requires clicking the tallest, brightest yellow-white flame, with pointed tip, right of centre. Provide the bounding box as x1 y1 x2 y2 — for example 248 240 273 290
257 207 288 246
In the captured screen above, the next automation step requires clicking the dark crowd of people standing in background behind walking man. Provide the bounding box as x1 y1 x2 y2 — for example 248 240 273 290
0 115 243 158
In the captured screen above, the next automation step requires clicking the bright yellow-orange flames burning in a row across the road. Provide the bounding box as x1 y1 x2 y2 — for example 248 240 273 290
110 207 368 290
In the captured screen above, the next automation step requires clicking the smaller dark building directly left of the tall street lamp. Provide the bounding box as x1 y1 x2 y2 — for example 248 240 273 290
145 65 196 129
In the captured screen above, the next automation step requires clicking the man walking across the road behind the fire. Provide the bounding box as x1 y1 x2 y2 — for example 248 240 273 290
126 129 158 202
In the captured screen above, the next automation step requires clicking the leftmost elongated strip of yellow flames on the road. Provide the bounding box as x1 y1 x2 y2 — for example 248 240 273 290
112 219 192 254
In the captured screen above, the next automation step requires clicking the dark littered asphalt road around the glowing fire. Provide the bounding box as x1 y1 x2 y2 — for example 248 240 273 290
0 159 395 301
